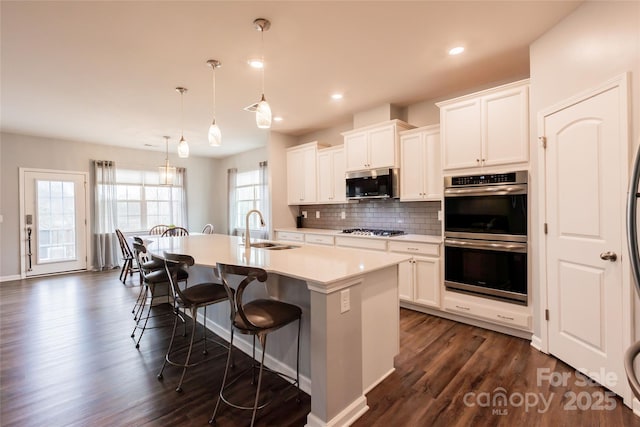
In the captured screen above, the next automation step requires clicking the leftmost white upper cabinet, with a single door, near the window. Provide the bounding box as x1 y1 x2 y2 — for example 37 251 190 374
287 141 326 205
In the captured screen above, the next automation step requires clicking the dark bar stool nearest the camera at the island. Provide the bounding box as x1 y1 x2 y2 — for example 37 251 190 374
209 263 302 426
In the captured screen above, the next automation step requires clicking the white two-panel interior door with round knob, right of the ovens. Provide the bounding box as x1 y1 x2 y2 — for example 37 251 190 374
543 78 630 397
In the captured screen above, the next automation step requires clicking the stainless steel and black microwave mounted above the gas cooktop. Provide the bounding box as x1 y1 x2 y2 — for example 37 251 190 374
346 169 400 200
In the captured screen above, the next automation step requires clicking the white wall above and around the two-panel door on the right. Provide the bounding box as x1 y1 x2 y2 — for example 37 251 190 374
529 1 640 336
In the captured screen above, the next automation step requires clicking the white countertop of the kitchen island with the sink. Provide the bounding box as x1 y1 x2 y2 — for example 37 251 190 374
145 229 411 285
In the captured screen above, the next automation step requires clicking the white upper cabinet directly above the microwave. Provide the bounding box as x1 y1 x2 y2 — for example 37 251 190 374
342 120 415 172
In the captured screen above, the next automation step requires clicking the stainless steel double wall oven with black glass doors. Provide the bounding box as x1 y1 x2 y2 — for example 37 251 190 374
444 171 528 305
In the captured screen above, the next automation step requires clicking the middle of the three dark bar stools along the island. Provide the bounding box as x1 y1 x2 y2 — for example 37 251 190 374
157 252 229 392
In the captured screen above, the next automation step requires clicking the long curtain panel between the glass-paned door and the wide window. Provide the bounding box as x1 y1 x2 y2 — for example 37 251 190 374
93 160 119 270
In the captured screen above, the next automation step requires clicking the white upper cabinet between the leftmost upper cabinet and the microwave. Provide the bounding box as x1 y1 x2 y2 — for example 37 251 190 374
317 145 347 203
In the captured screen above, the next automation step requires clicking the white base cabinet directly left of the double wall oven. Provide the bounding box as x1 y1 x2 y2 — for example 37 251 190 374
389 241 441 308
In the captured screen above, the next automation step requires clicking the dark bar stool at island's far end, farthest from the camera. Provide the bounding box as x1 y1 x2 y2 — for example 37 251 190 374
131 241 189 348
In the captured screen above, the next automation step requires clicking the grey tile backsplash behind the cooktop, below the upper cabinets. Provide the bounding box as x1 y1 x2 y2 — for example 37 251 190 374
298 200 442 236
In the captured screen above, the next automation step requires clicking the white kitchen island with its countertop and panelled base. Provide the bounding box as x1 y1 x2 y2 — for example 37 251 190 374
148 234 409 427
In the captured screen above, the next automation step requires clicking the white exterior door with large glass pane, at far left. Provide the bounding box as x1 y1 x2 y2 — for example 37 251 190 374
21 170 87 276
